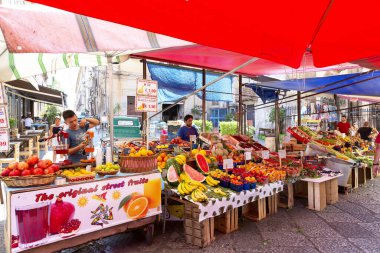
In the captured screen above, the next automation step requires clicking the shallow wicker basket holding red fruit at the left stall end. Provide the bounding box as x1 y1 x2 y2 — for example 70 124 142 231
0 174 57 188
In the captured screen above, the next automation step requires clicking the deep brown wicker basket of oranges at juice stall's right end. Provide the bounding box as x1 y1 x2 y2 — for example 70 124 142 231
119 154 159 173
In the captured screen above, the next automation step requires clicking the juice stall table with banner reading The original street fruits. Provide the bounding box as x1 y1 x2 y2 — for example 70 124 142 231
4 171 161 253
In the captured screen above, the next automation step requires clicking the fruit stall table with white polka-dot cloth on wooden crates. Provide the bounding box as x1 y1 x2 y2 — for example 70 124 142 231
163 181 284 247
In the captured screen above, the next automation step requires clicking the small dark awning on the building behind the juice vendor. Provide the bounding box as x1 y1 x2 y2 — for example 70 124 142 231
5 80 66 106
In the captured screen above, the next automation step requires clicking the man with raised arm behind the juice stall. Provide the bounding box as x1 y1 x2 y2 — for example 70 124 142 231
62 110 100 163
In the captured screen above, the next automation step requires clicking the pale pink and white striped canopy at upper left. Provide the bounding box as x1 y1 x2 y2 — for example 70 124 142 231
0 4 191 81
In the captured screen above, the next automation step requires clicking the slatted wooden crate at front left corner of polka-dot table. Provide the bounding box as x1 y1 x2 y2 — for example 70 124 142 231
183 204 215 248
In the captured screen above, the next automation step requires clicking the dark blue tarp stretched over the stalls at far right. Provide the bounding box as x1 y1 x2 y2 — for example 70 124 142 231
258 71 380 96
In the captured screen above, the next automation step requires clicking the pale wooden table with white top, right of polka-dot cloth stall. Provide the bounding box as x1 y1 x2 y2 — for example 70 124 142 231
301 174 343 211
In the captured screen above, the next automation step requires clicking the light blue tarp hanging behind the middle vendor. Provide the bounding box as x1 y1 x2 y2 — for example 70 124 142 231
148 63 233 103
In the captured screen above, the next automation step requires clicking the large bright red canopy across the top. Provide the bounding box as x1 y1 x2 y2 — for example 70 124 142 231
27 0 380 68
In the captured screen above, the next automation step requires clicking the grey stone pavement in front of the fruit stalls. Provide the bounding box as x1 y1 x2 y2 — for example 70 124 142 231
0 178 380 253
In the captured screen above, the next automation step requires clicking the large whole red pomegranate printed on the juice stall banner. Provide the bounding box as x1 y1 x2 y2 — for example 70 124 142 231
50 198 75 234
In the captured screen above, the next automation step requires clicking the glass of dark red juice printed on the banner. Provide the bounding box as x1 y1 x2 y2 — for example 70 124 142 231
15 201 50 248
